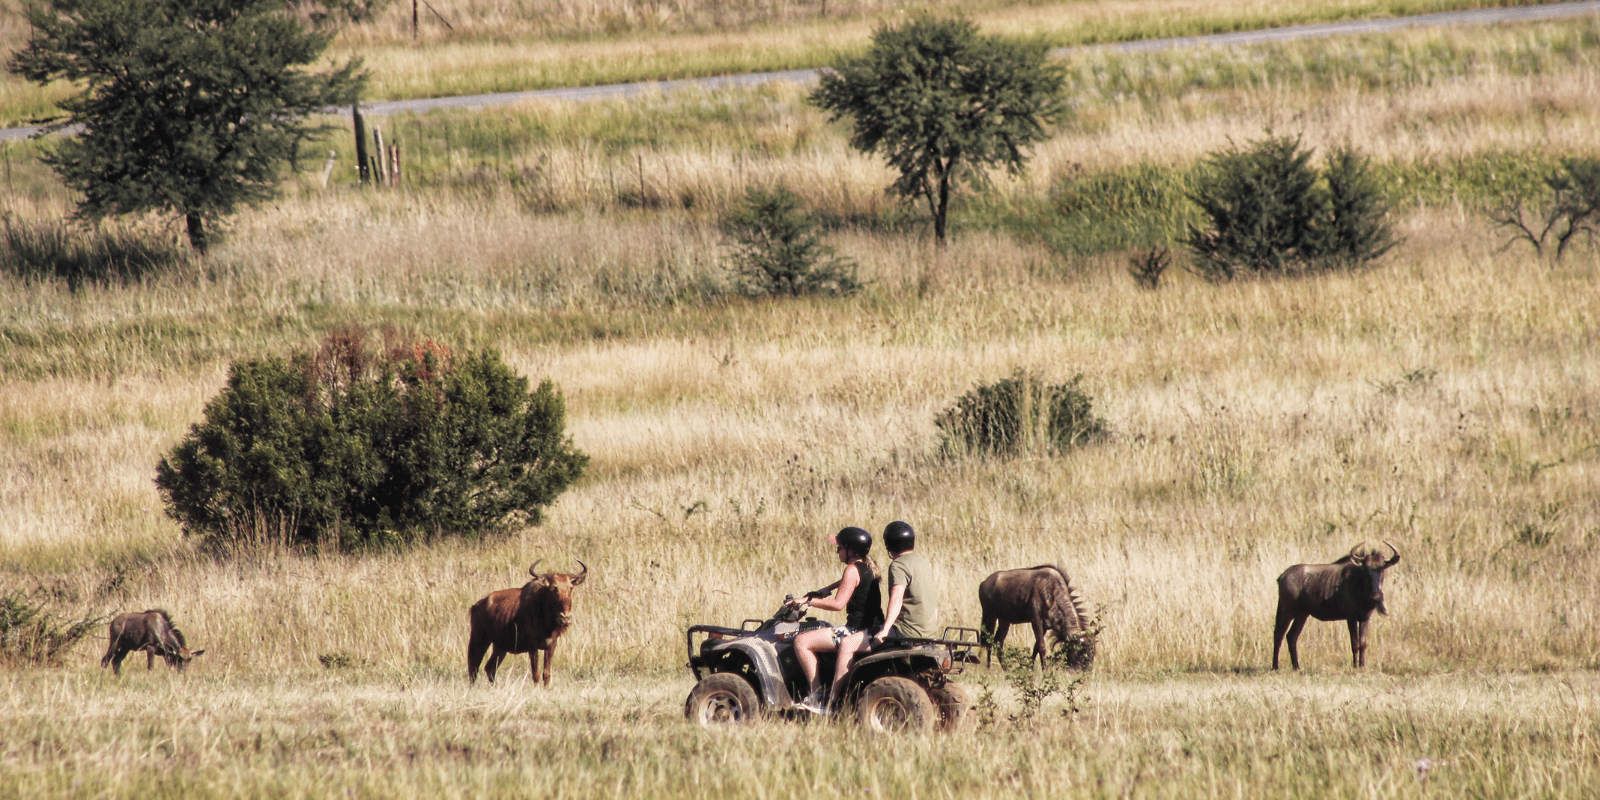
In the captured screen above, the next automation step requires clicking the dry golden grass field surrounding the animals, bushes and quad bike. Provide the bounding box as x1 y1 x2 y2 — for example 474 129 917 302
0 10 1600 798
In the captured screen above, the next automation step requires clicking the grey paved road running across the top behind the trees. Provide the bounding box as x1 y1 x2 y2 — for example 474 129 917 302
0 0 1600 141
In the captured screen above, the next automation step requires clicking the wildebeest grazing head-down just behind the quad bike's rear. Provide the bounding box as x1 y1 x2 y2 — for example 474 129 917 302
978 565 1094 669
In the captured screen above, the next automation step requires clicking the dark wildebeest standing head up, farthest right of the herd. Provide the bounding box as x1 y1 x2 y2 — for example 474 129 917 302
1272 542 1400 669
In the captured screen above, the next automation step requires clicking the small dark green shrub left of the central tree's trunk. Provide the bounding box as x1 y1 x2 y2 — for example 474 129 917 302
723 187 861 296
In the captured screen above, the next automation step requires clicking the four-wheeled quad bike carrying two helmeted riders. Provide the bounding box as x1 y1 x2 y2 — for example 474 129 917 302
683 595 979 733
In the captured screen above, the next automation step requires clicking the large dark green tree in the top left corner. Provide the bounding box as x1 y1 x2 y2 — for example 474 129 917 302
10 0 365 253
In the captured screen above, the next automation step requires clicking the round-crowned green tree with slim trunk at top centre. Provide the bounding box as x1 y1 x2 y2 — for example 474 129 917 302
811 18 1066 245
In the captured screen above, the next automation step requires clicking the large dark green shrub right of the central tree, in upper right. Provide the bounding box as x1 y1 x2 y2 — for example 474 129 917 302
1184 136 1395 280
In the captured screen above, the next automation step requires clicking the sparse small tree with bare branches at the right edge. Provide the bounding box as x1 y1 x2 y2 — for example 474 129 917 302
1486 157 1600 261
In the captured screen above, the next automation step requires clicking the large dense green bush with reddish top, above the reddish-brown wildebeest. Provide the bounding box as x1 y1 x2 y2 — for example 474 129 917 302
155 331 589 549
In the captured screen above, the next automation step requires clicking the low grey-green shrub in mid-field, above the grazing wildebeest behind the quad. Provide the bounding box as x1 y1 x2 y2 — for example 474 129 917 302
934 370 1106 456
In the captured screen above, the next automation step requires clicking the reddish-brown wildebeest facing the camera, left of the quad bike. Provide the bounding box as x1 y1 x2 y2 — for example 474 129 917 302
467 562 589 686
